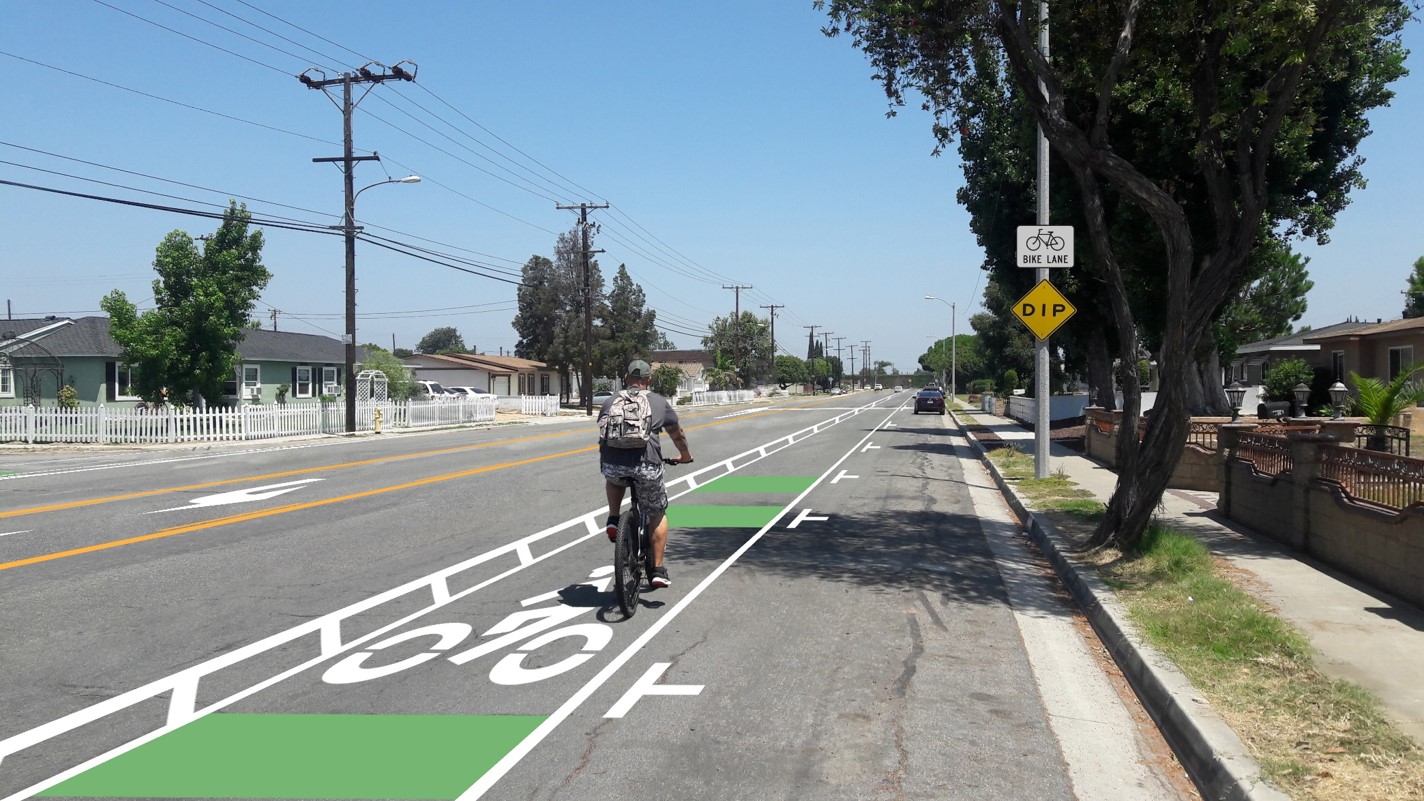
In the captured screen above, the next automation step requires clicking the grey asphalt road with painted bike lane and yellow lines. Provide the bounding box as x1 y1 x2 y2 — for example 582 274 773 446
0 392 1189 801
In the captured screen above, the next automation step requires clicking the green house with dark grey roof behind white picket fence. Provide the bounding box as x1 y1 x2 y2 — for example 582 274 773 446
0 316 365 406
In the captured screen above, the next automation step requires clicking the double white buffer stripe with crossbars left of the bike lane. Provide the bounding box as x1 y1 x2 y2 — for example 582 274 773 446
0 399 884 801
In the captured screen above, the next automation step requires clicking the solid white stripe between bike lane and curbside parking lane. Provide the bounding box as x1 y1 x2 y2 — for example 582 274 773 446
457 403 904 801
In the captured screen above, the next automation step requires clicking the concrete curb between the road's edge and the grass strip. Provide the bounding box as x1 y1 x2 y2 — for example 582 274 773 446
954 416 1290 801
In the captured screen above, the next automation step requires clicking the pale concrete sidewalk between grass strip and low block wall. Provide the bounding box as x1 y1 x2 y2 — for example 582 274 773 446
956 409 1424 744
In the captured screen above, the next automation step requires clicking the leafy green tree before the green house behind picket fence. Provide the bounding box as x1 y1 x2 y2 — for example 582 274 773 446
100 201 272 405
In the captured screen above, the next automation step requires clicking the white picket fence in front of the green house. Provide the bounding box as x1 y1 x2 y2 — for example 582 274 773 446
0 396 496 445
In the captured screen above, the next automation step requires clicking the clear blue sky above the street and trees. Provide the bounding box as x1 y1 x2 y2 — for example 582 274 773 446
0 0 1424 368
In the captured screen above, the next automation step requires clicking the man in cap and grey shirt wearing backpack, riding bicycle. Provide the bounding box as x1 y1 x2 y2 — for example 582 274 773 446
598 359 692 587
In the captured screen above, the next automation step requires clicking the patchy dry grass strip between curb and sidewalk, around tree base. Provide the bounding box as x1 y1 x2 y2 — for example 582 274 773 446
990 448 1424 801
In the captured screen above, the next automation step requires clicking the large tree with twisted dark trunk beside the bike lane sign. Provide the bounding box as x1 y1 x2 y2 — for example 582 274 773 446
817 0 1408 546
